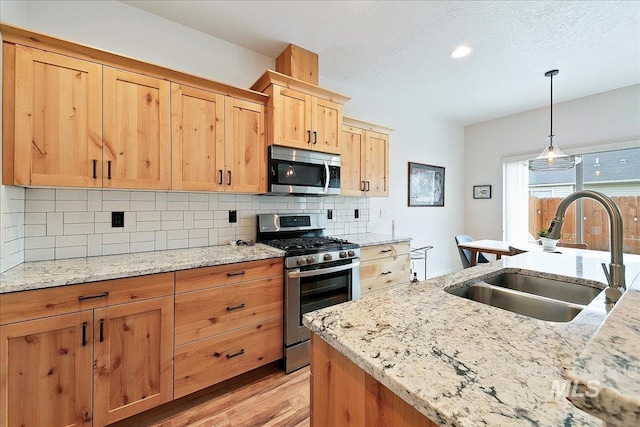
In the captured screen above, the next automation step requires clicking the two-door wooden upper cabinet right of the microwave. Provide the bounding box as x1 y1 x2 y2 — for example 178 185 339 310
340 118 391 197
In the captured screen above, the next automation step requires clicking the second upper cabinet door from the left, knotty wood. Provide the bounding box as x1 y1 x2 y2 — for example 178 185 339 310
103 67 171 190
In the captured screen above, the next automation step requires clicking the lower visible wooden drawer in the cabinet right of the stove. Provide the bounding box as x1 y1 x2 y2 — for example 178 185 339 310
360 254 411 294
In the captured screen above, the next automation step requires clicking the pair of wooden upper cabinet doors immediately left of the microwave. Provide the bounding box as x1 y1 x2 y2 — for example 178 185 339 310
171 84 267 193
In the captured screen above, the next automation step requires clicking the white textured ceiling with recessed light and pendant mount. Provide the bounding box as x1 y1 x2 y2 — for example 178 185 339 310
123 0 640 125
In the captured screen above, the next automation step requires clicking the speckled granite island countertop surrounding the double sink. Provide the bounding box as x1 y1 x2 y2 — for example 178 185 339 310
304 251 640 426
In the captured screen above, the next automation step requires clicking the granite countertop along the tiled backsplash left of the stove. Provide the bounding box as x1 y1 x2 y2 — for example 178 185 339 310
0 243 284 294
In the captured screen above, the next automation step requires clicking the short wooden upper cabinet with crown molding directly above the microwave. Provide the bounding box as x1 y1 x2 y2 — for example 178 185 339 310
251 70 349 154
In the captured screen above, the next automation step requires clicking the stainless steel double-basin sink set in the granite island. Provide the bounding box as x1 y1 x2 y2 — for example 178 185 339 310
447 273 602 322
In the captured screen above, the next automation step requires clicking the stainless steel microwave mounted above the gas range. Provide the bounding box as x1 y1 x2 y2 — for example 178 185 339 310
269 145 340 196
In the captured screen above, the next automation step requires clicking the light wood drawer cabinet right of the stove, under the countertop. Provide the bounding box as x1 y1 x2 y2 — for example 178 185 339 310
360 242 411 295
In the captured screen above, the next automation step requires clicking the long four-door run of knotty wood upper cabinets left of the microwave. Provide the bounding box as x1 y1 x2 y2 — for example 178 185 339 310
0 23 268 193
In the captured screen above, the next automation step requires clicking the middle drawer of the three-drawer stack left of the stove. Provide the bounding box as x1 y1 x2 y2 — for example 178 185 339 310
175 276 283 346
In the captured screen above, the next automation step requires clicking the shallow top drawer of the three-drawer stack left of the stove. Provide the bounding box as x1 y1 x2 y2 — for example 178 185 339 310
176 258 283 293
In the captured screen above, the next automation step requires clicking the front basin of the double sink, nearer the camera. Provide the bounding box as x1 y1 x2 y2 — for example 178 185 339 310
447 282 584 322
